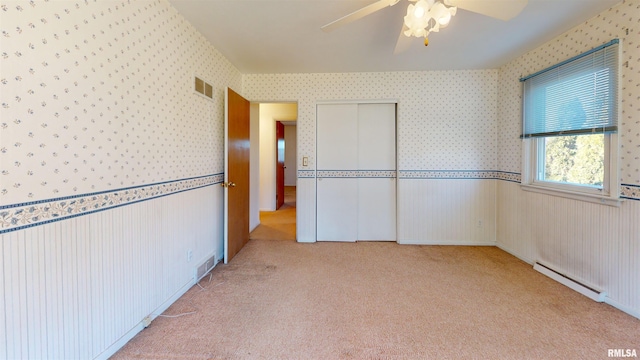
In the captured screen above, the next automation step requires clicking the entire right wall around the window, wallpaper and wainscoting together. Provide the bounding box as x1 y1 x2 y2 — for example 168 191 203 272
497 0 640 317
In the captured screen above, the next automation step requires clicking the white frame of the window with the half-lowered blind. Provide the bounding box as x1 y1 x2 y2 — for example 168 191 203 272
520 42 623 206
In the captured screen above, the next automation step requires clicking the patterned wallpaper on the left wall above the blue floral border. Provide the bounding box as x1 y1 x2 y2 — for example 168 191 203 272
0 0 242 205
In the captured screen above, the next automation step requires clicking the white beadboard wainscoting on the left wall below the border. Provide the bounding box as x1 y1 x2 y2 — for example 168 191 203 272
0 184 223 359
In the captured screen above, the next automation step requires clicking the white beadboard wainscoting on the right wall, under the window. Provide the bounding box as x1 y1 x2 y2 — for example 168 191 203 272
497 181 640 318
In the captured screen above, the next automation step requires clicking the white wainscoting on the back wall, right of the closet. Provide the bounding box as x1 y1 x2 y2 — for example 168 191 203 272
398 178 496 245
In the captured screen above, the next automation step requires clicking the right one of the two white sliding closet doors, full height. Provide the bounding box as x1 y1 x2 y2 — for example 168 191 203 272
357 104 396 241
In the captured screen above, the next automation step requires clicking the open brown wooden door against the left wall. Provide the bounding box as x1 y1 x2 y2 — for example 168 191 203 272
222 88 249 264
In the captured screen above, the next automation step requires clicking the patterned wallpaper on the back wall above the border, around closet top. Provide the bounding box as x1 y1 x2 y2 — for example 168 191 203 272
243 70 498 173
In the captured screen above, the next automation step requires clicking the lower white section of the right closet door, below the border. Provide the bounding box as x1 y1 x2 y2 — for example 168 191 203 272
358 178 396 241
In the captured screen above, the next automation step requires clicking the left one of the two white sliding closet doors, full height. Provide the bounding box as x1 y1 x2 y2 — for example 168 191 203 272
316 104 358 241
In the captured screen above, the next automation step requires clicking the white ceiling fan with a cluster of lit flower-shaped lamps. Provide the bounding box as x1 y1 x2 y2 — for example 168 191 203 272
321 0 528 54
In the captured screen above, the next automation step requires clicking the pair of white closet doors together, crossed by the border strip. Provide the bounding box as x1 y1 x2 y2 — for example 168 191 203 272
316 104 396 241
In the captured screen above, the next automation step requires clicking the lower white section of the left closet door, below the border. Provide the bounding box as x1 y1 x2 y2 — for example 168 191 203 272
316 178 358 241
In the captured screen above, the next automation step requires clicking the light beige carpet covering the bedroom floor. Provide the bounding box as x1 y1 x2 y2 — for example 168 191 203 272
114 240 640 359
